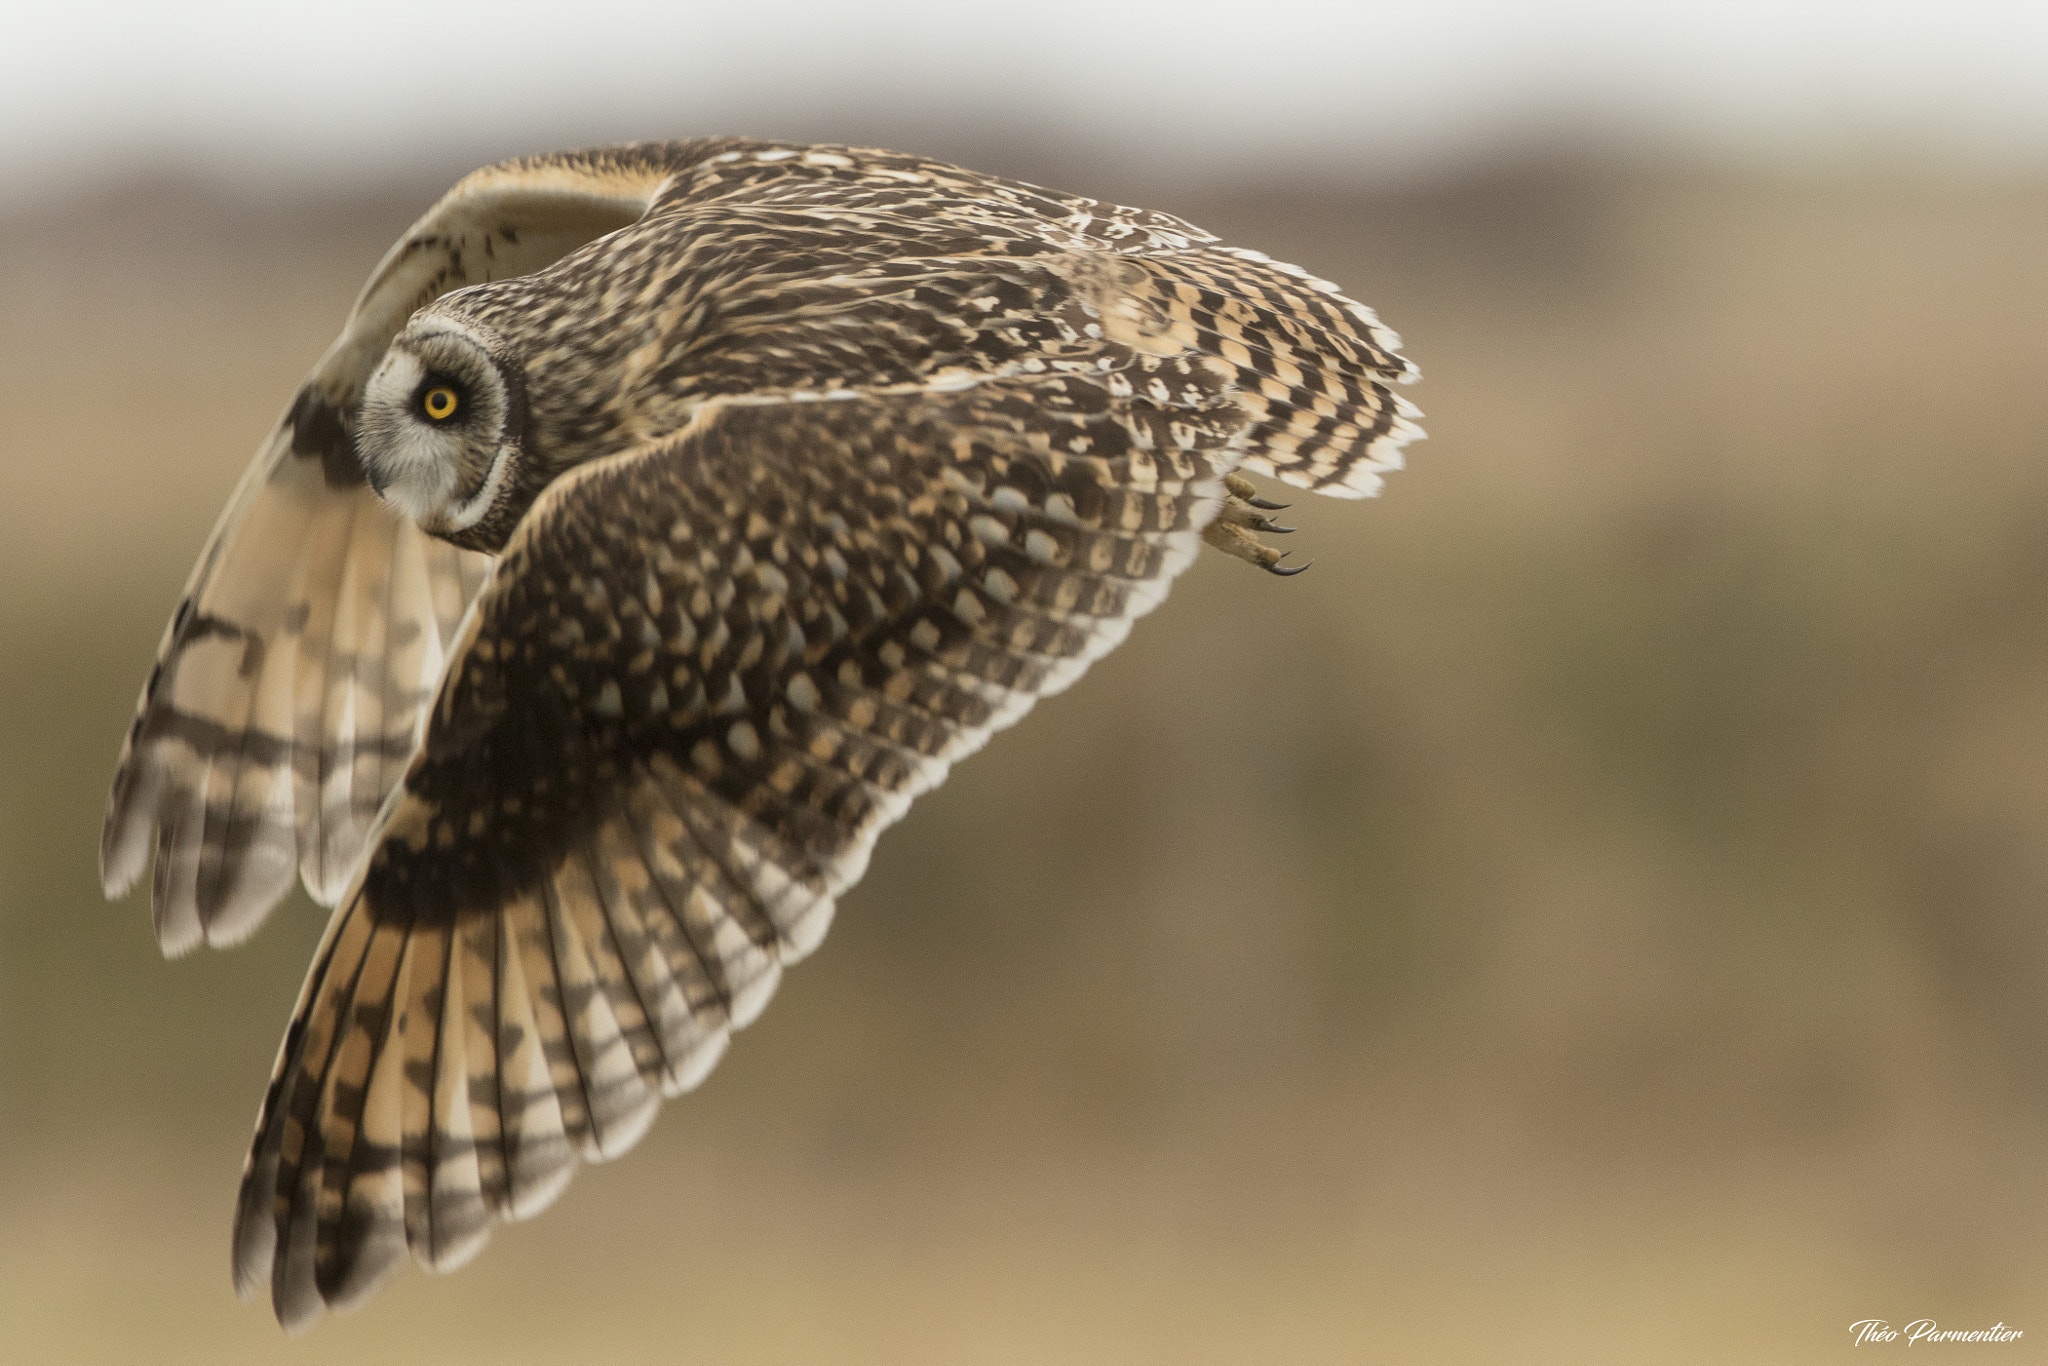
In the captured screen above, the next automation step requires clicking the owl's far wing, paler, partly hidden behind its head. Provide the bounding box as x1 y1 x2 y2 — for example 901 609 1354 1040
100 147 704 954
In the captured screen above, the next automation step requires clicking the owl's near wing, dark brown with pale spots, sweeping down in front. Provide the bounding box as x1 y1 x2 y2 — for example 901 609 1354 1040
236 348 1245 1327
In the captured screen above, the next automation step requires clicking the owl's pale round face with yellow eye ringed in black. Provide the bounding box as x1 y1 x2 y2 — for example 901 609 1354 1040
356 313 537 551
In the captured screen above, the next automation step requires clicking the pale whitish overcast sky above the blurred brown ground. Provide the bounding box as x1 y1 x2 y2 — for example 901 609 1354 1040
0 0 2048 205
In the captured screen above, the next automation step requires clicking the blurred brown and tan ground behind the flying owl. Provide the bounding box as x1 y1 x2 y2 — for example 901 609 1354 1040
0 150 2048 1366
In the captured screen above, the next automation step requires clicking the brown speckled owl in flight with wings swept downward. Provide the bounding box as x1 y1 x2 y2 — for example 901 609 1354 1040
100 139 1421 1331
